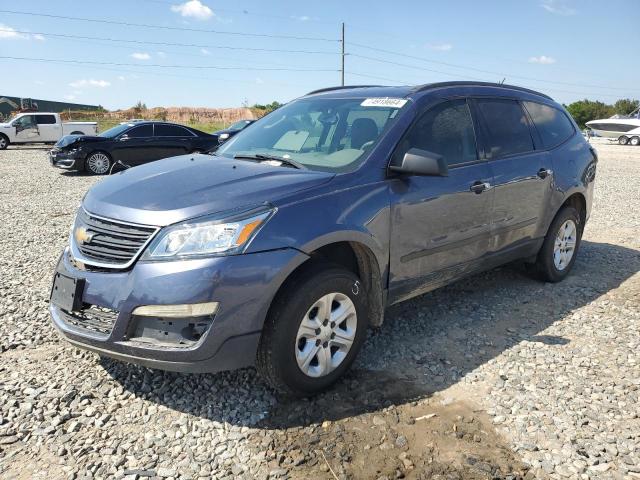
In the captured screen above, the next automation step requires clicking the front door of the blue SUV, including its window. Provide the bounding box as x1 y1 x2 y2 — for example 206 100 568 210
389 99 493 303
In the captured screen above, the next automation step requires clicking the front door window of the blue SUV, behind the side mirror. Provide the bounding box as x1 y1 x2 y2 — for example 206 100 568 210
394 100 478 166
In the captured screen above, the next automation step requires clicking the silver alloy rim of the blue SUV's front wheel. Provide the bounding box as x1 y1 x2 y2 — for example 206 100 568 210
295 292 358 377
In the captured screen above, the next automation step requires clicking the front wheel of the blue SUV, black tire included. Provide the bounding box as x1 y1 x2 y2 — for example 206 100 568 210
256 264 369 396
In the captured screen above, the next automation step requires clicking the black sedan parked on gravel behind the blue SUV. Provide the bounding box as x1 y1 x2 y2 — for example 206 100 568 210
49 121 218 175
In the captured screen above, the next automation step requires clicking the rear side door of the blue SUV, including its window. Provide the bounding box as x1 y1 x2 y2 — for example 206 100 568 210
473 98 552 252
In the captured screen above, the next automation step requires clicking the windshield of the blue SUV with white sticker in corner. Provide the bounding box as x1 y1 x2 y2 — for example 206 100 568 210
216 97 406 172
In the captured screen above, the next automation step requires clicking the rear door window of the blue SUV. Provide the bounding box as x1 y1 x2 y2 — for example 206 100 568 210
476 98 533 158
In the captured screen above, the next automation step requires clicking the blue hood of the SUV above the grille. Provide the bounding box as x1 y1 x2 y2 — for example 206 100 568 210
83 155 335 226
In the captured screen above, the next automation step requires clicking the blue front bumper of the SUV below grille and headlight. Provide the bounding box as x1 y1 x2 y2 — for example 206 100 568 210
49 249 308 373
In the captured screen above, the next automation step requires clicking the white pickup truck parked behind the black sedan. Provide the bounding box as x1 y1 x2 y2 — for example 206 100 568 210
0 112 98 150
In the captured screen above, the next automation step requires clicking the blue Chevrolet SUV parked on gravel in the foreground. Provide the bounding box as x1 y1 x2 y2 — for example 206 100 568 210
50 82 597 395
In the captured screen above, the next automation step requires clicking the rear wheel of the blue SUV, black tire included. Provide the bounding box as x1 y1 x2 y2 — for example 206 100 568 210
535 207 584 283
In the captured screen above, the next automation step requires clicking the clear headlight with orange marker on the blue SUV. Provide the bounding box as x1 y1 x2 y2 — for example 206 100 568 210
143 206 275 260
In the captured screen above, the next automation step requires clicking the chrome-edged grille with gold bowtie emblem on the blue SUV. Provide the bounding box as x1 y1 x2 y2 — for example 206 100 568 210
71 209 158 268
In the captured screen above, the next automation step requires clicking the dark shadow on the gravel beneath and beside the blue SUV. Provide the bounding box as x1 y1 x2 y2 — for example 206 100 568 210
101 241 640 429
